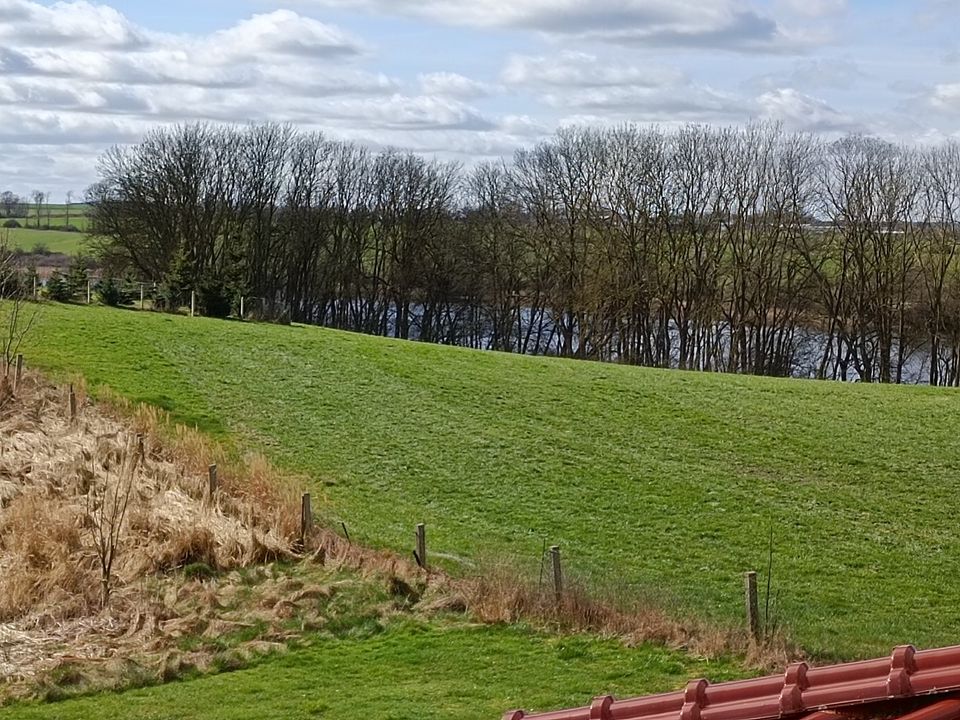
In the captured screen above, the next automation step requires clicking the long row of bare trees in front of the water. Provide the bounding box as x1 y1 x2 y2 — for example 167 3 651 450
88 124 960 385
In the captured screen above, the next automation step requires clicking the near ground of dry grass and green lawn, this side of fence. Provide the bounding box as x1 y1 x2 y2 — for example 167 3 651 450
0 370 748 720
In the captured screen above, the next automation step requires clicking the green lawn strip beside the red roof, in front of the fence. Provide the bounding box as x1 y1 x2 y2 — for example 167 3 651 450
0 623 730 720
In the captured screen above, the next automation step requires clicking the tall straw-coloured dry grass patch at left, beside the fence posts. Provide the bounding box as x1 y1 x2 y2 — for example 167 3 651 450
0 373 299 623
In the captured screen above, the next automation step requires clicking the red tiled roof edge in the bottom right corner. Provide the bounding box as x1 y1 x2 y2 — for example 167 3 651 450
503 645 960 720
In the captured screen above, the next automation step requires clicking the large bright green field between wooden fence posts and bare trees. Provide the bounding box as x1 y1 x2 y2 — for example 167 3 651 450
20 306 960 657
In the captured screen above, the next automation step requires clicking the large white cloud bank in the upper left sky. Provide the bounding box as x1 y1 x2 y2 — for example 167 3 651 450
0 0 408 190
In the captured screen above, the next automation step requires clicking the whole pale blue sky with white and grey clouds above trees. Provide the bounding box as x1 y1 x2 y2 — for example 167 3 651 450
0 0 960 201
